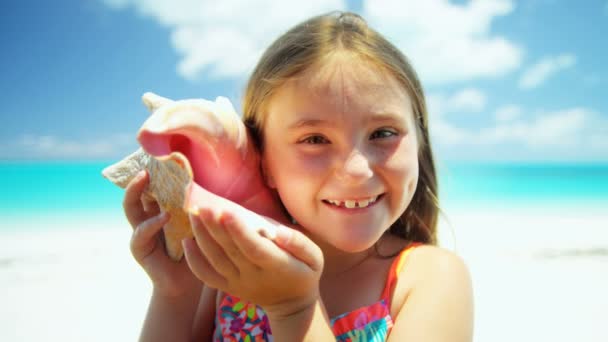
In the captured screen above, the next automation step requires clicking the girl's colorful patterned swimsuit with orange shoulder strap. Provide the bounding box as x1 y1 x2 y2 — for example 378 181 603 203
213 243 420 342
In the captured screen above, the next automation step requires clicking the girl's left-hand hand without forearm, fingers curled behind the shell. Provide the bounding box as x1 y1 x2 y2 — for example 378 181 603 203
123 171 202 297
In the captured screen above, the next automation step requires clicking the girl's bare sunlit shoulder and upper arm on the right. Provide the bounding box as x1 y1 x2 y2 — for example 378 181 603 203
388 247 473 342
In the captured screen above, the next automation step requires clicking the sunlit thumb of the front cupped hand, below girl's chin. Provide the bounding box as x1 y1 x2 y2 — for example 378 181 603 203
274 224 323 272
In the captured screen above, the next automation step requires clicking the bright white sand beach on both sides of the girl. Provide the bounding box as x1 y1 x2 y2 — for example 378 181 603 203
0 210 608 342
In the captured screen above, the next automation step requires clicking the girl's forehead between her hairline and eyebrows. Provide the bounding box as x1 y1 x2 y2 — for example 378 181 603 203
267 56 412 125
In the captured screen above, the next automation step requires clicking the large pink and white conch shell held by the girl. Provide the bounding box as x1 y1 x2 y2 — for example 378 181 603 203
102 93 288 261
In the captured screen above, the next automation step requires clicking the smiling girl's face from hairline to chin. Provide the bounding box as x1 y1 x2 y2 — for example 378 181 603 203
263 58 418 252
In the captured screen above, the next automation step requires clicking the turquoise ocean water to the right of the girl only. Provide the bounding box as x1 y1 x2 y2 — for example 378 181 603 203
438 163 608 212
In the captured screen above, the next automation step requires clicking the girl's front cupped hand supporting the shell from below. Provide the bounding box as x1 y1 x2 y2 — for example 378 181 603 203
184 204 323 316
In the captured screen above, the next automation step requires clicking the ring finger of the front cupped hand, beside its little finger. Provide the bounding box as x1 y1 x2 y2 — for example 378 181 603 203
190 209 240 278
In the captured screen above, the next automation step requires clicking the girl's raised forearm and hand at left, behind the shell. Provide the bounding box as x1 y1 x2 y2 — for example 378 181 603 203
123 173 213 341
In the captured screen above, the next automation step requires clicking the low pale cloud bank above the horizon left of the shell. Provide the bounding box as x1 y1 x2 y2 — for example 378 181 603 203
0 133 137 159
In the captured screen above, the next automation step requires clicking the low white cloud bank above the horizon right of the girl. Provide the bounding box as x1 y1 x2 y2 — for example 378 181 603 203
428 96 608 160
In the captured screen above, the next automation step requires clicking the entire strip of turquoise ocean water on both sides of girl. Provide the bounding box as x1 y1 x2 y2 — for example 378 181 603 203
0 161 608 229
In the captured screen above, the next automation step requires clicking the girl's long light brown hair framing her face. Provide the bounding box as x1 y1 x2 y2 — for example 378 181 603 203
243 12 439 244
